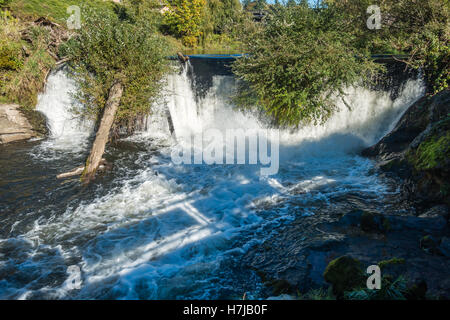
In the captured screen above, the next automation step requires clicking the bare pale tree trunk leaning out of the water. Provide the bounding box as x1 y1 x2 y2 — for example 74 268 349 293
81 82 123 183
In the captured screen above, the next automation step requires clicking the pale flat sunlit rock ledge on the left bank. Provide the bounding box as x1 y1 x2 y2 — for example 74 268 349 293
0 104 47 144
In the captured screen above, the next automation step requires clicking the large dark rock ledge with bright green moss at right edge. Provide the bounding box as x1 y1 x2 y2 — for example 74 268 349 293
362 90 450 211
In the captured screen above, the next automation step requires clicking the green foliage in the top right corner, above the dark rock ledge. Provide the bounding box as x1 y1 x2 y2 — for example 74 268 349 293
326 0 450 93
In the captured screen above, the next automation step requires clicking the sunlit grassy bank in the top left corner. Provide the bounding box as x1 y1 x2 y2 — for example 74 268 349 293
0 0 113 109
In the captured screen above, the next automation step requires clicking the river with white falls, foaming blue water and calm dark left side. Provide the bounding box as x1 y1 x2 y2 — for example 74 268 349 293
0 61 424 299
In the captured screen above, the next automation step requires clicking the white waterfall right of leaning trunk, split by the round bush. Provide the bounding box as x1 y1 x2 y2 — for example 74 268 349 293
147 64 425 156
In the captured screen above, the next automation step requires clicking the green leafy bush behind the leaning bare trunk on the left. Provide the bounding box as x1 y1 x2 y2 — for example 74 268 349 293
62 8 169 129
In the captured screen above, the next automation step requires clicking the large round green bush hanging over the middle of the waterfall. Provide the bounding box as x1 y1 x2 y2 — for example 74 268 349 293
234 6 380 125
